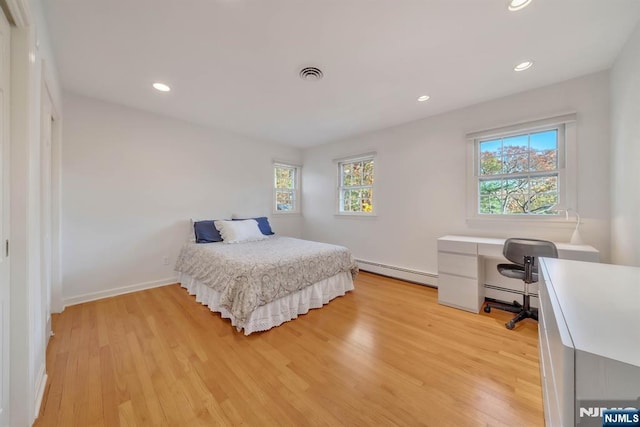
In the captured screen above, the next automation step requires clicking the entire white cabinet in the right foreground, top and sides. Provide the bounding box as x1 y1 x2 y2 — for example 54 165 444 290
538 258 640 426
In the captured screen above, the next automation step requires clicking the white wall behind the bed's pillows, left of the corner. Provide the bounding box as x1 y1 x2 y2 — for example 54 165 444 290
62 94 302 304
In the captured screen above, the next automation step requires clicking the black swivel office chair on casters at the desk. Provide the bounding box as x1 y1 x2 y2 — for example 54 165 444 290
484 238 558 329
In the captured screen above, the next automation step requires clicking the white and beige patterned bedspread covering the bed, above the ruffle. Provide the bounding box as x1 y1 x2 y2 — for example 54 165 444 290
175 236 358 327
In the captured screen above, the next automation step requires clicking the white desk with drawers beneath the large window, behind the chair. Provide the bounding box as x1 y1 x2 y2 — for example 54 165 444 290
438 236 599 313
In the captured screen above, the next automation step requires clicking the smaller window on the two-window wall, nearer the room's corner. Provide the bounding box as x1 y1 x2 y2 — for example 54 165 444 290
338 155 374 215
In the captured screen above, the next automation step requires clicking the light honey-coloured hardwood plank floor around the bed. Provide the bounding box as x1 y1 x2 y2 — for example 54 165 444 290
35 273 544 427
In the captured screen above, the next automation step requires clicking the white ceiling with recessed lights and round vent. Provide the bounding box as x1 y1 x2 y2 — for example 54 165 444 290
43 0 640 147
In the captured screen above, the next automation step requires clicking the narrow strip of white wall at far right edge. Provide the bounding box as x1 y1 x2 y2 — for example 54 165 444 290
611 25 640 266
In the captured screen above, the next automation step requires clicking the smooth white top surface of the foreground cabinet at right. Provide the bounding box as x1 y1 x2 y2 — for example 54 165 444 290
540 258 640 367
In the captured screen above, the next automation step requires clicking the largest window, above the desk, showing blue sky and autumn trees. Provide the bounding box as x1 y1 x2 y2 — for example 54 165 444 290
464 117 572 218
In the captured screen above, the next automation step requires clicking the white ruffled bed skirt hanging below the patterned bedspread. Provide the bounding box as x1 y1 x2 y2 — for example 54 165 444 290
178 271 353 335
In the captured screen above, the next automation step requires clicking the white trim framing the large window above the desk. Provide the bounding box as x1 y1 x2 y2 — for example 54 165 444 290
466 113 577 223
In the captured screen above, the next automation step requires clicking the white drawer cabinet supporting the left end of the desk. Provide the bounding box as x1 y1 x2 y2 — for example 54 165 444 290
438 239 484 313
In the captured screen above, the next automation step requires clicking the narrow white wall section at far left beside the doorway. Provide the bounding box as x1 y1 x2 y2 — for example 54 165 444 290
9 0 60 425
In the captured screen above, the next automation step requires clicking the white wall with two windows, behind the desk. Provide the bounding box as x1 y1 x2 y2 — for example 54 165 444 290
303 72 610 280
